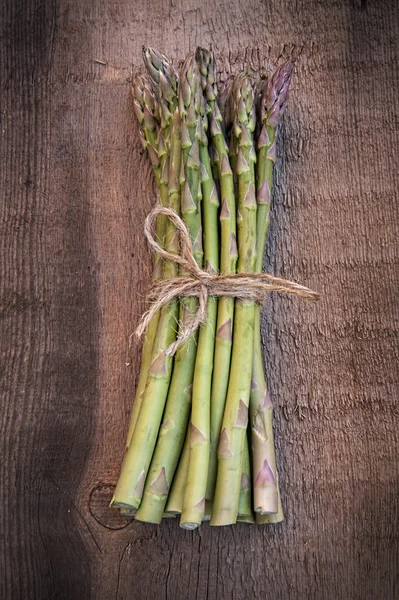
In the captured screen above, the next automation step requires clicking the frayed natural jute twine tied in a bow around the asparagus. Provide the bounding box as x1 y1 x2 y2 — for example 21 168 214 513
135 207 320 356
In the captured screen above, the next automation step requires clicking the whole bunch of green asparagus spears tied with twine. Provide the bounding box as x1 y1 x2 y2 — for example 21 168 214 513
112 47 293 529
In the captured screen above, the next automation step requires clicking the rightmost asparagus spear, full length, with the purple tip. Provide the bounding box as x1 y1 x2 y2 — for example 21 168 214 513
249 61 293 520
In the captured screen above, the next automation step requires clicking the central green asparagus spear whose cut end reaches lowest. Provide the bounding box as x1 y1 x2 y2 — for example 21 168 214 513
180 52 219 529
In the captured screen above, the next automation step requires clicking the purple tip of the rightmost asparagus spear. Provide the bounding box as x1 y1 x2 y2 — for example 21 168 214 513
261 60 294 128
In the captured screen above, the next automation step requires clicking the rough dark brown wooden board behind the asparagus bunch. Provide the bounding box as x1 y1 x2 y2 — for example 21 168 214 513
0 0 399 600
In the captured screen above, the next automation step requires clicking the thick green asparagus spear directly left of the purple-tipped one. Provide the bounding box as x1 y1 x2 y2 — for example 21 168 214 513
211 75 256 525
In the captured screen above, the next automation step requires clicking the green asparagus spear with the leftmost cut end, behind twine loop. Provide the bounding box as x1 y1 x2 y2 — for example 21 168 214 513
111 49 179 509
